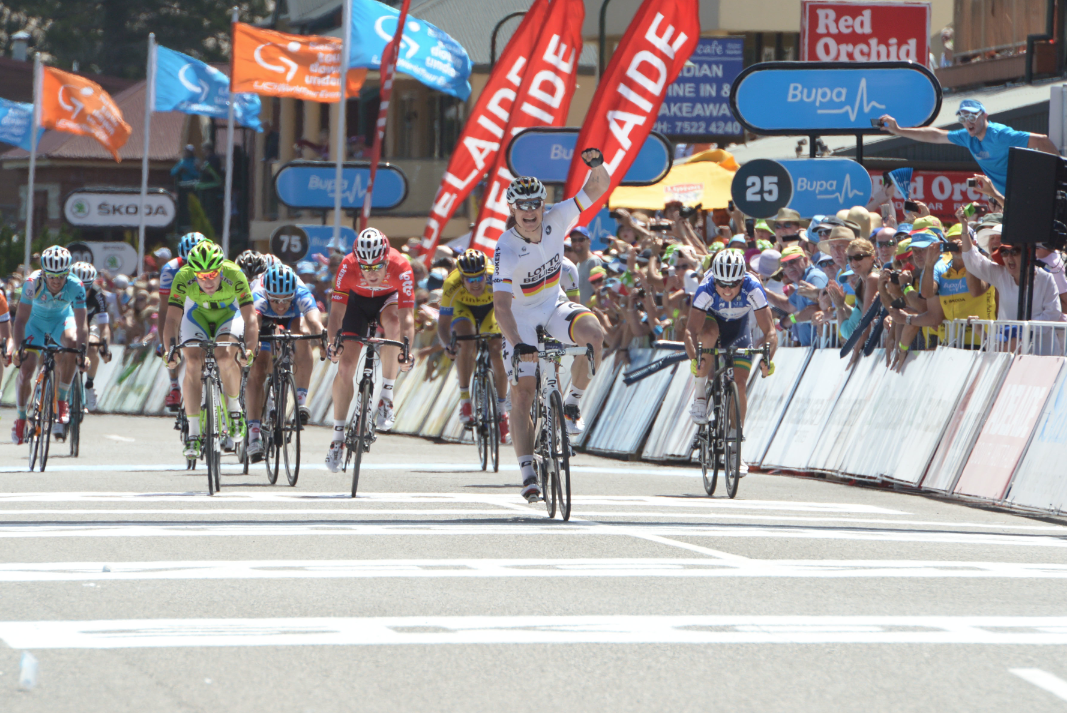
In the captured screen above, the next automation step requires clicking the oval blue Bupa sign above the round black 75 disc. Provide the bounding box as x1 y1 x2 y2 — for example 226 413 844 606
274 161 408 210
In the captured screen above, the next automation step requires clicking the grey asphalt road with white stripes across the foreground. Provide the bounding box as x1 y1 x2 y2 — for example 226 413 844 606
0 410 1067 713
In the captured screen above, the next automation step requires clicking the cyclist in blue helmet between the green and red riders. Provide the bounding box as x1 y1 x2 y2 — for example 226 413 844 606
245 264 323 460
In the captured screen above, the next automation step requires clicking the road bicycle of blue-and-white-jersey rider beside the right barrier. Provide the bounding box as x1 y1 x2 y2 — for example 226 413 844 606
692 343 770 498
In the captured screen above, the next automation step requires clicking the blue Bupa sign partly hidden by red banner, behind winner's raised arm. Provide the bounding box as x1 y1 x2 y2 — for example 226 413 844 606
507 127 674 186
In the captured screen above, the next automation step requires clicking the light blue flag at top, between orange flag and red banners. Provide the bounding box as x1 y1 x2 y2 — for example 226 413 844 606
348 0 471 101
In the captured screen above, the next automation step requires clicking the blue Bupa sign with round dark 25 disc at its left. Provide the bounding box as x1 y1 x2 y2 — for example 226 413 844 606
731 158 871 218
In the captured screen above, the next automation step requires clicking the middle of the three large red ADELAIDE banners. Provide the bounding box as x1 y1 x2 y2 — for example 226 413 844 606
471 0 586 255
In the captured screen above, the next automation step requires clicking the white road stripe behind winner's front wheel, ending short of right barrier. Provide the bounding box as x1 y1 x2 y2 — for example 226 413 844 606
0 493 908 514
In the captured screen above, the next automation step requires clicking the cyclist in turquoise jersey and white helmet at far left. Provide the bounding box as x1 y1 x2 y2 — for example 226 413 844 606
11 245 89 443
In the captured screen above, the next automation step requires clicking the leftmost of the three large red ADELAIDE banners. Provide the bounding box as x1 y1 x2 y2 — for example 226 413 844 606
423 0 548 254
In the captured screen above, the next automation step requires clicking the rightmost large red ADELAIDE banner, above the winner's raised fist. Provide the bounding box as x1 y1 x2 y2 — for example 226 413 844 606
563 0 700 225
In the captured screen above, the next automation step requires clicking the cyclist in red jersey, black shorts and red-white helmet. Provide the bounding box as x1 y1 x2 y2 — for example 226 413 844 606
327 227 415 473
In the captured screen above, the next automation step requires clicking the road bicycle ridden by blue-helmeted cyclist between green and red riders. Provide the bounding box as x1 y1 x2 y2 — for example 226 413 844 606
259 330 327 486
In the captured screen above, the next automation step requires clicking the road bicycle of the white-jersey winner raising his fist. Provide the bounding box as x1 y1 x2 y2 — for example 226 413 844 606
511 327 596 522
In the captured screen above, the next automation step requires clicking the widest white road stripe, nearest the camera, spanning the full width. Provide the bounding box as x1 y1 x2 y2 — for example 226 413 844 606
10 616 1067 649
